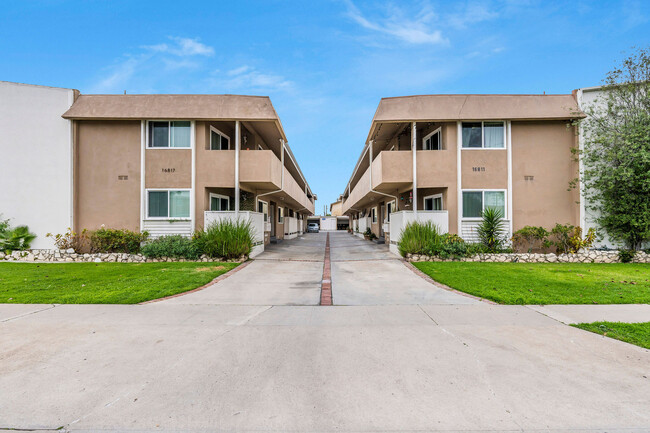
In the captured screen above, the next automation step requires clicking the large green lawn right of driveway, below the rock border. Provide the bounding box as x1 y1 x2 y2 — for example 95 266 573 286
414 262 650 305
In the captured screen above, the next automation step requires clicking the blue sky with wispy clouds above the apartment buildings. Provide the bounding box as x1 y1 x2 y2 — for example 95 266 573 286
0 0 650 212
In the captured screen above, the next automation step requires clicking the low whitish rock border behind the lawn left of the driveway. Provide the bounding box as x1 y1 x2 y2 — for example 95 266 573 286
0 249 248 263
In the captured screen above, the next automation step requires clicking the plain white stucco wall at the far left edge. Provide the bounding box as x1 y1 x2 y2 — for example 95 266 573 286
0 81 74 249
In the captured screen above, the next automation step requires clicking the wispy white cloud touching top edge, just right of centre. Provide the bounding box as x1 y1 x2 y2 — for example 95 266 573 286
345 0 449 45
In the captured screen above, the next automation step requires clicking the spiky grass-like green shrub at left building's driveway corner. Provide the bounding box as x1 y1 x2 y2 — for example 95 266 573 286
193 219 254 259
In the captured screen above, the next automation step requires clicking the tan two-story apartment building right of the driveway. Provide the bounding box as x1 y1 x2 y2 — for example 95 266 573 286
342 95 584 251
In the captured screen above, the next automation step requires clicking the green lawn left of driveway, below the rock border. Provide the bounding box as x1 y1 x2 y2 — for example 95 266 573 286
0 262 237 304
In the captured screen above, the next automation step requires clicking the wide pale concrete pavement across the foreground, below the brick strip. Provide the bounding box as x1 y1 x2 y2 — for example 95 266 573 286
0 302 650 432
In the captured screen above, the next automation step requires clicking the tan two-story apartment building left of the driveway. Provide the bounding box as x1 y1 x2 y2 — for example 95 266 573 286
0 81 316 250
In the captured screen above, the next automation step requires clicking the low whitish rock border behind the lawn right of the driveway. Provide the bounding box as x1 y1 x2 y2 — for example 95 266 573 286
405 250 650 263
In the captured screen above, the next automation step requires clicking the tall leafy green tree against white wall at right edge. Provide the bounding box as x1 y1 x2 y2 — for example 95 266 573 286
580 48 650 250
